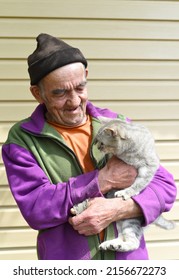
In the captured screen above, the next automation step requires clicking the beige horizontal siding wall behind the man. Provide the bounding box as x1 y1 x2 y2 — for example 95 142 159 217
0 0 179 259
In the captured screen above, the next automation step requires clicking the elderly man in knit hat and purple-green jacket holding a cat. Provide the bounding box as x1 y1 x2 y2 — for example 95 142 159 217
3 34 176 260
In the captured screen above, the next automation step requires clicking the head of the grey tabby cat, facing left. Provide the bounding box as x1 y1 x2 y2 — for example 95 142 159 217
95 119 128 154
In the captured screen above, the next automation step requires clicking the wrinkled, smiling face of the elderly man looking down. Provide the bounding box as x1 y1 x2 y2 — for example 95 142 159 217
31 63 88 127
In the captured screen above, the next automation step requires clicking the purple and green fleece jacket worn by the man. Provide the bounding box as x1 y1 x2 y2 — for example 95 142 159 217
2 102 176 260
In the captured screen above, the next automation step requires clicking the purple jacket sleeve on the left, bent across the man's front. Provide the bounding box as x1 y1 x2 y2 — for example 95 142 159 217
2 144 102 230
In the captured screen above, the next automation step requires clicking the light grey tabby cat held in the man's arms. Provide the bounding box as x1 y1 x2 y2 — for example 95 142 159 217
71 118 174 252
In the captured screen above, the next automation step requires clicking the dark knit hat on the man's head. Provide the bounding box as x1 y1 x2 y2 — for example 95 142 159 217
27 33 87 85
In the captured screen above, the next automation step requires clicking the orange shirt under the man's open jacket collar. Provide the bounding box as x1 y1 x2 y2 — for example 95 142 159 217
48 116 104 241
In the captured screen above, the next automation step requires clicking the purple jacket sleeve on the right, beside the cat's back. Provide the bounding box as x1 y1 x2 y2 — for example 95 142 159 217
133 166 177 226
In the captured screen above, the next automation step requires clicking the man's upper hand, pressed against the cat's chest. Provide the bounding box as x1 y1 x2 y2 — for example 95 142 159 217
98 156 137 194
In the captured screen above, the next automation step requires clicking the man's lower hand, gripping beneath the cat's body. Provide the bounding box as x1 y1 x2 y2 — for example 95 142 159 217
69 197 142 236
